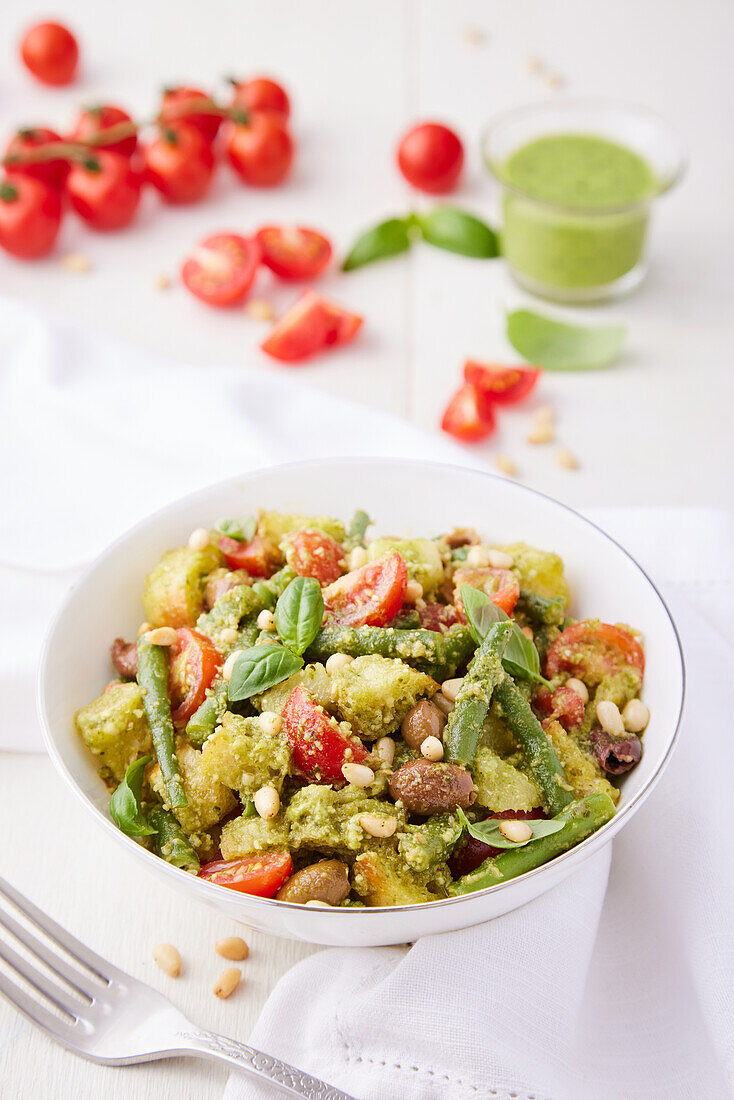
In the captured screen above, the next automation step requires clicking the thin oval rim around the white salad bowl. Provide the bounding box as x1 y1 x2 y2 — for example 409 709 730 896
36 457 686 920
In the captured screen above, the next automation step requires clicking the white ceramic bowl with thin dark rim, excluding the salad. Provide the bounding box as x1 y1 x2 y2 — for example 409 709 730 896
39 459 683 946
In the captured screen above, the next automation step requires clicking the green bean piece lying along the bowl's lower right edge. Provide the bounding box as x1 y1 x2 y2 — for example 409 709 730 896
449 791 614 895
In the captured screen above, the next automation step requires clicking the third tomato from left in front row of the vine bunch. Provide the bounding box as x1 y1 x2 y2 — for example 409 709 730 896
144 122 215 204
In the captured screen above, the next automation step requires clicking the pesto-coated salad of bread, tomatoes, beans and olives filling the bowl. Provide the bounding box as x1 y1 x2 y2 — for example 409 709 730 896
76 512 649 906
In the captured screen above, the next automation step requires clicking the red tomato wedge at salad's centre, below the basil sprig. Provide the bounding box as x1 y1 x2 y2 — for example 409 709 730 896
283 685 369 783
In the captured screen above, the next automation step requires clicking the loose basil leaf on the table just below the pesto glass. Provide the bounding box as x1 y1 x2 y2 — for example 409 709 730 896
507 309 627 371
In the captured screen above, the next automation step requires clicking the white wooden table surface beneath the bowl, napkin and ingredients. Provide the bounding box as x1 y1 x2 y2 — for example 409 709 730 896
0 0 734 1100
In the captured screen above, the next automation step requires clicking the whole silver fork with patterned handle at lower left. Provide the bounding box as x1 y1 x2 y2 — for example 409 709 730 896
0 879 353 1100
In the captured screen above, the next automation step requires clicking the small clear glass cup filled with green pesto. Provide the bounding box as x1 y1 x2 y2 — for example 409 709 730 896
482 101 684 304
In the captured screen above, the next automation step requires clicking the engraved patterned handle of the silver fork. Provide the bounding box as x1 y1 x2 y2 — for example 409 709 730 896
176 1030 354 1100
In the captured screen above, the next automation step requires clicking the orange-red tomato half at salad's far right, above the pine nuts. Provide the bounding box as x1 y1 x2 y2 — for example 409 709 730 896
546 619 645 688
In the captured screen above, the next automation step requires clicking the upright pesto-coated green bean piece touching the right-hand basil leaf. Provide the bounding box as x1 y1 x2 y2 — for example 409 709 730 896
443 622 513 768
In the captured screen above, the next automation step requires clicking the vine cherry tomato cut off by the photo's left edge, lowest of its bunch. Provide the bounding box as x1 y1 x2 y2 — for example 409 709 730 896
0 176 62 260
